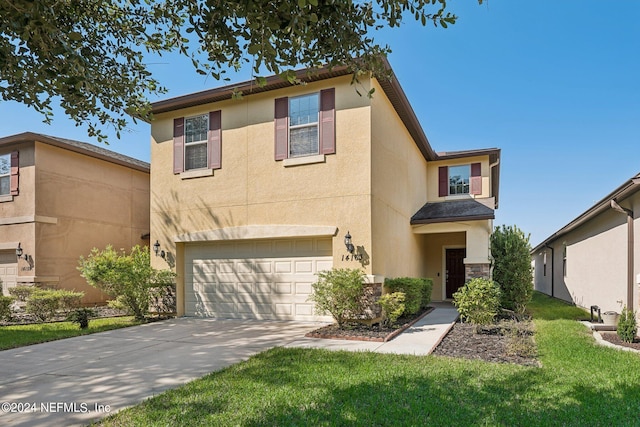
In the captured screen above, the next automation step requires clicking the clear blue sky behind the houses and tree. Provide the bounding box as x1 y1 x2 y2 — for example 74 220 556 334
0 0 640 246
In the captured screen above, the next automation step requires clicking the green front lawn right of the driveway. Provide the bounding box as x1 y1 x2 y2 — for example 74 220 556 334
95 294 640 426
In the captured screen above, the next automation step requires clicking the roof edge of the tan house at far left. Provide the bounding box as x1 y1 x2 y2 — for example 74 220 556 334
0 132 149 172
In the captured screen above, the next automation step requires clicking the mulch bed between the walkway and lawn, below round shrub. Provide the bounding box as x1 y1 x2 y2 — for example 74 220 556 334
433 320 540 367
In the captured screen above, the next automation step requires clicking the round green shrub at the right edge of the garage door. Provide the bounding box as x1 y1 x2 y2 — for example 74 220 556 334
309 268 364 327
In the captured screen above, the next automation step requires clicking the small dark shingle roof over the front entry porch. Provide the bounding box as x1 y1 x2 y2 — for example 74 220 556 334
411 199 495 225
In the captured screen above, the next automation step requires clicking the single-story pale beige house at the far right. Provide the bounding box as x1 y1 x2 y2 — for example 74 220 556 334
531 174 640 313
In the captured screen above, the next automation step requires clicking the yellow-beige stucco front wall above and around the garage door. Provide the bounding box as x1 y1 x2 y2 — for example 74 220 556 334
151 76 372 280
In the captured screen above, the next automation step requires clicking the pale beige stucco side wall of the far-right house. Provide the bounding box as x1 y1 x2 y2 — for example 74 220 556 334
533 192 640 312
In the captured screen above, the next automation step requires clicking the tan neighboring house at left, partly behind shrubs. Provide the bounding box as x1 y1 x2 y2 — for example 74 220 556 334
0 133 149 304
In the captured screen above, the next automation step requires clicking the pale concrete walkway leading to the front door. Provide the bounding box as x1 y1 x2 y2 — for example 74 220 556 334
287 303 458 356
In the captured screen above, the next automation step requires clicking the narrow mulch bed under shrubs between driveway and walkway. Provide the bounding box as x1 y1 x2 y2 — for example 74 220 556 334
305 307 433 342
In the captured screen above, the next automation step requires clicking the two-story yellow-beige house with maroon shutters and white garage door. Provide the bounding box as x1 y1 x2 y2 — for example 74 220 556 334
151 59 500 320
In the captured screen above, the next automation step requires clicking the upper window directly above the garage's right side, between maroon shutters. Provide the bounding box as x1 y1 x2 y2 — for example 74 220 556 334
289 93 320 157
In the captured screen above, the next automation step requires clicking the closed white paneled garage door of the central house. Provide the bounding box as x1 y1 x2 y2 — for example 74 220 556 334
185 238 333 321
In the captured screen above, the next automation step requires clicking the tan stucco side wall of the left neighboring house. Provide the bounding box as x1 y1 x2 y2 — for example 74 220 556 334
30 142 149 303
